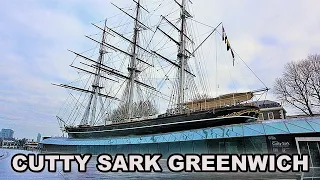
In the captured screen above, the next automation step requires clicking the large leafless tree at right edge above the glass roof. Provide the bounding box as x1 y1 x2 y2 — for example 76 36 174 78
273 54 320 116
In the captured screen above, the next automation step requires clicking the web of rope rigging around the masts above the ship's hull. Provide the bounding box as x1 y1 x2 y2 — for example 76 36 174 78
55 0 266 131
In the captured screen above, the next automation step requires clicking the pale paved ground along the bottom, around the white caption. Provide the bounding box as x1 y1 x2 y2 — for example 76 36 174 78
0 149 320 180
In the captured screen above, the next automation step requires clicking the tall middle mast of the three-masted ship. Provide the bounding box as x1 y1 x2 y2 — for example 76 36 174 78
127 0 140 121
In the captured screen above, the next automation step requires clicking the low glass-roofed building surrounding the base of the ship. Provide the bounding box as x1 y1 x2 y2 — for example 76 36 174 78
41 117 320 167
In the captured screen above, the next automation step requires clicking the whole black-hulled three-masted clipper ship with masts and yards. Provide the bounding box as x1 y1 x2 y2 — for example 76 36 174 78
53 0 268 138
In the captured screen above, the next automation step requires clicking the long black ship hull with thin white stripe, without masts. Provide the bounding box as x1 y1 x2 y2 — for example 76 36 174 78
66 106 257 138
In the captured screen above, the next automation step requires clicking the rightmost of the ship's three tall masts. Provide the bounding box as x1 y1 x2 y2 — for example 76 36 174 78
177 0 187 113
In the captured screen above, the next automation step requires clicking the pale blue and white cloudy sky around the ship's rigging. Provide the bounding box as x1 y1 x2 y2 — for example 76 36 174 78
0 0 320 139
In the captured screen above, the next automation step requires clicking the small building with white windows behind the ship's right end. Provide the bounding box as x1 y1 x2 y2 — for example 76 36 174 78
254 100 287 120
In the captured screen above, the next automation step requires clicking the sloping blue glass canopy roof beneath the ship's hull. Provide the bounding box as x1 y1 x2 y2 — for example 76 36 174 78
41 117 320 145
